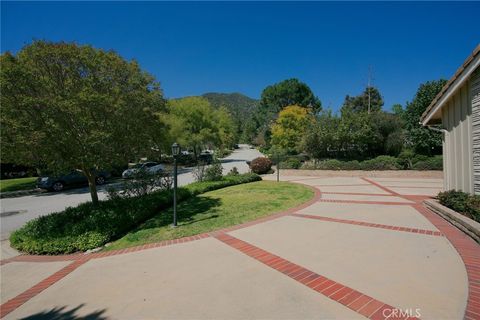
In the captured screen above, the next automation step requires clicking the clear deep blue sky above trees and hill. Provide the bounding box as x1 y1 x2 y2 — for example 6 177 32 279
1 1 480 110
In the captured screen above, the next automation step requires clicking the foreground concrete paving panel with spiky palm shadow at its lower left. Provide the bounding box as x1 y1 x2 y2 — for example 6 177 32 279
6 238 362 319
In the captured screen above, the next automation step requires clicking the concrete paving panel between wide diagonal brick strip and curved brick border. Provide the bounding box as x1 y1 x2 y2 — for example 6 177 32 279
231 216 468 319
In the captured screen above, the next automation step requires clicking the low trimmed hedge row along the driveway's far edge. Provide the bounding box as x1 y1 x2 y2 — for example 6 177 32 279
296 156 443 170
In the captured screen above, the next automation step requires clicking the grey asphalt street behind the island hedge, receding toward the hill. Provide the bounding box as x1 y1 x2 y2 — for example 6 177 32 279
0 145 262 242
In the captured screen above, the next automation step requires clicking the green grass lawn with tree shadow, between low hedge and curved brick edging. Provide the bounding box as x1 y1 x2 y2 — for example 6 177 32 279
105 181 313 250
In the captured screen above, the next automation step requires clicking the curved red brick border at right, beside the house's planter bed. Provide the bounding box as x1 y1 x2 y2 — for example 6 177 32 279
413 204 480 320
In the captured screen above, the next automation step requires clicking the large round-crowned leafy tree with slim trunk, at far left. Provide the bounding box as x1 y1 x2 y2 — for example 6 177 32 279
0 41 164 203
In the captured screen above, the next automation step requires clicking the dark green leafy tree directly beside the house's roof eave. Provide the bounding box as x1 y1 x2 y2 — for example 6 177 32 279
402 79 446 155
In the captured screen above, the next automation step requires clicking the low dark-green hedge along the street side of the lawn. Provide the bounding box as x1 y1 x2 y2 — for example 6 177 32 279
10 173 261 254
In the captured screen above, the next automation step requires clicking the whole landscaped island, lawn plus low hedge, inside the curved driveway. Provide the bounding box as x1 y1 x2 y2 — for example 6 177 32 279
10 173 313 254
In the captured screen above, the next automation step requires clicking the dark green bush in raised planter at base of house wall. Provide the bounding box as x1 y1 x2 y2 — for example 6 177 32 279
437 190 480 222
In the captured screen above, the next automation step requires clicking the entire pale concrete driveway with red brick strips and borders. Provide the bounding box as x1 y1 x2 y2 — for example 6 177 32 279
1 176 480 319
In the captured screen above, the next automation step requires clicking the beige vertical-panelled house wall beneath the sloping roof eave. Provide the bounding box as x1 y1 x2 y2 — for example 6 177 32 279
442 71 474 193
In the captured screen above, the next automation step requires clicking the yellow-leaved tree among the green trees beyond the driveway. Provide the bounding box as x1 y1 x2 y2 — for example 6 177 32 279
272 105 313 153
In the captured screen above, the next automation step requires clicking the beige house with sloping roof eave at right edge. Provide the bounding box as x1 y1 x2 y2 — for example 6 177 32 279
420 45 480 194
